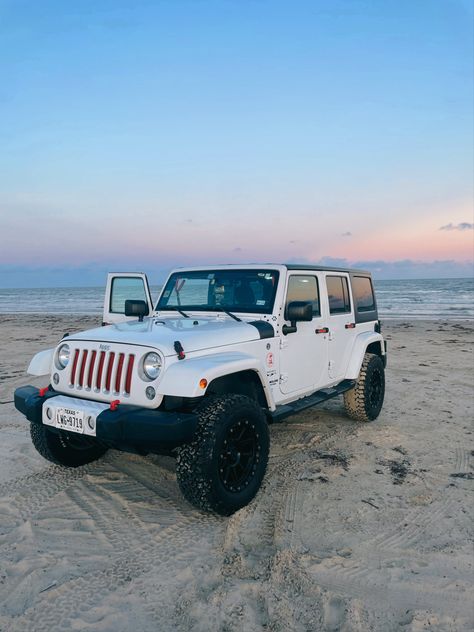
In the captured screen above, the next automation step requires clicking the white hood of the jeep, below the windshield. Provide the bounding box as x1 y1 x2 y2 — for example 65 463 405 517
67 316 271 356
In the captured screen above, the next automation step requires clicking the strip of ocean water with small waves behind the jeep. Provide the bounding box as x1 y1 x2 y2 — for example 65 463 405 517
0 278 474 320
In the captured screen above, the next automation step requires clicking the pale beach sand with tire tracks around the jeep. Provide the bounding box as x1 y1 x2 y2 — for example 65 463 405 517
0 315 474 632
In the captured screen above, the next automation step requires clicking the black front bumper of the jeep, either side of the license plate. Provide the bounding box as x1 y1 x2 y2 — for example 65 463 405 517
14 386 197 453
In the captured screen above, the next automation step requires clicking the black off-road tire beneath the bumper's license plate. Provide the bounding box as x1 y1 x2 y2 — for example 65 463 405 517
30 422 107 467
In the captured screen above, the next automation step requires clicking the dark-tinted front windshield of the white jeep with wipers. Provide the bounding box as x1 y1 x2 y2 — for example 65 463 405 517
156 269 279 314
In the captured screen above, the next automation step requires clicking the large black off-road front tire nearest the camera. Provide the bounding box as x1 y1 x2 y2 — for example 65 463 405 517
176 393 270 516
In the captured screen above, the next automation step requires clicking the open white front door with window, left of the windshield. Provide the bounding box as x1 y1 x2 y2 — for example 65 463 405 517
102 272 153 325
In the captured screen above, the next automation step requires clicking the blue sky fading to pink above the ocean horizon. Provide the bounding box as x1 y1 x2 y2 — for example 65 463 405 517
0 0 474 287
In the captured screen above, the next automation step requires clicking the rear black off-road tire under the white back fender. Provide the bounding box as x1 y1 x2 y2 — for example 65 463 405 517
344 353 385 421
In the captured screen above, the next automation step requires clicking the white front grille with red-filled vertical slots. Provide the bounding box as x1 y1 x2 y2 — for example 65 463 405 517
69 349 135 395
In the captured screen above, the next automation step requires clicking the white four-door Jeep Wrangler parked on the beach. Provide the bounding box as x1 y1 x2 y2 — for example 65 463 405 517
15 264 386 515
